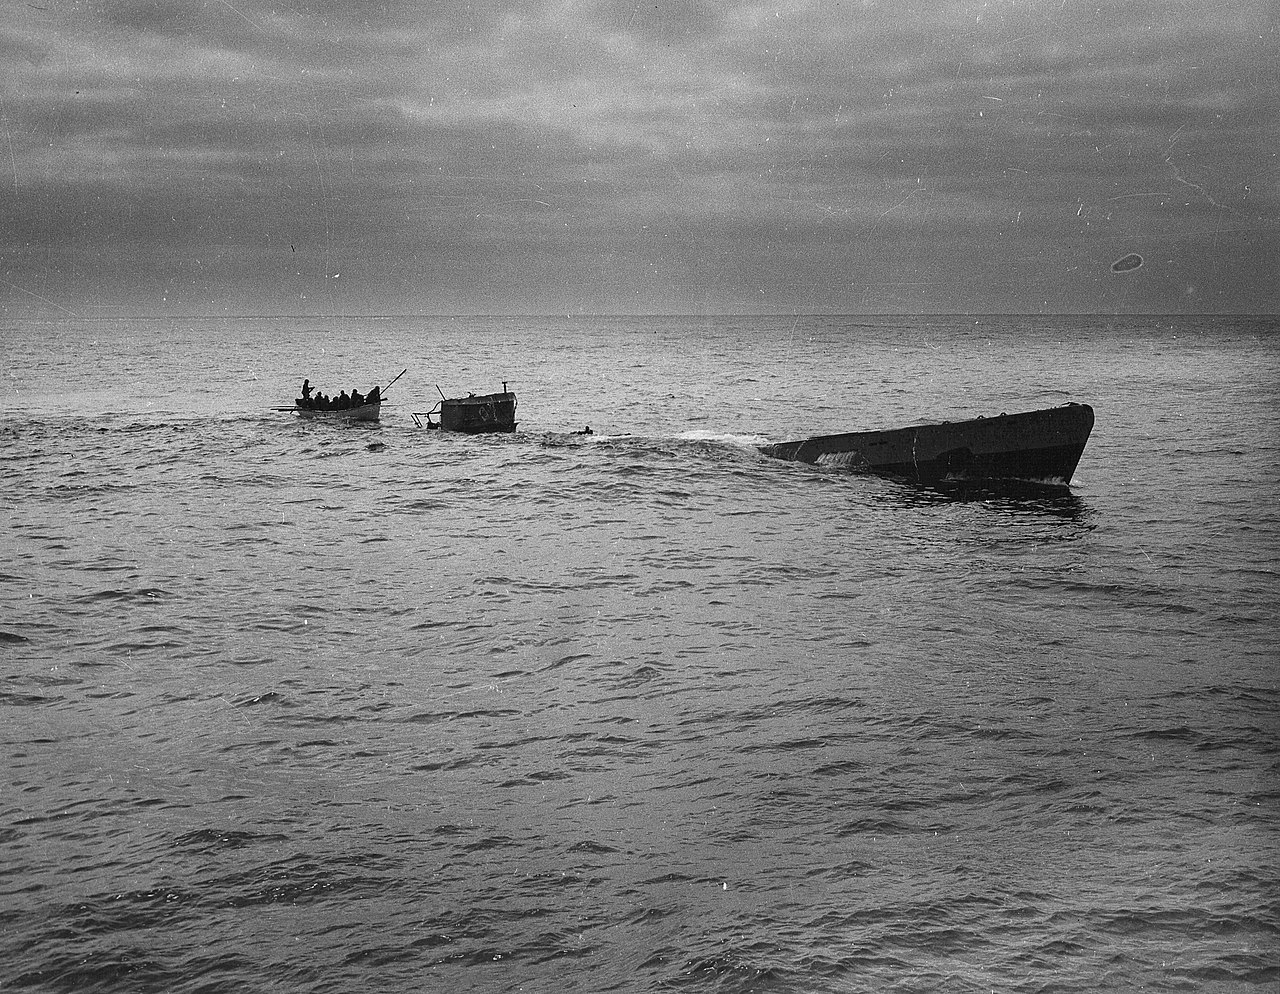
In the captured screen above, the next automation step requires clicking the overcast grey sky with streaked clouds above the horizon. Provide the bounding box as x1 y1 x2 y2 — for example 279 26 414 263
0 0 1280 317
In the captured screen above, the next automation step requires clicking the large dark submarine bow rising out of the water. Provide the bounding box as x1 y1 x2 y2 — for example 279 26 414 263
760 404 1093 486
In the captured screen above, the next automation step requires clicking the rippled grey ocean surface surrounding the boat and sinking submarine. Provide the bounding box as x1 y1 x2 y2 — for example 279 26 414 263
0 316 1280 994
